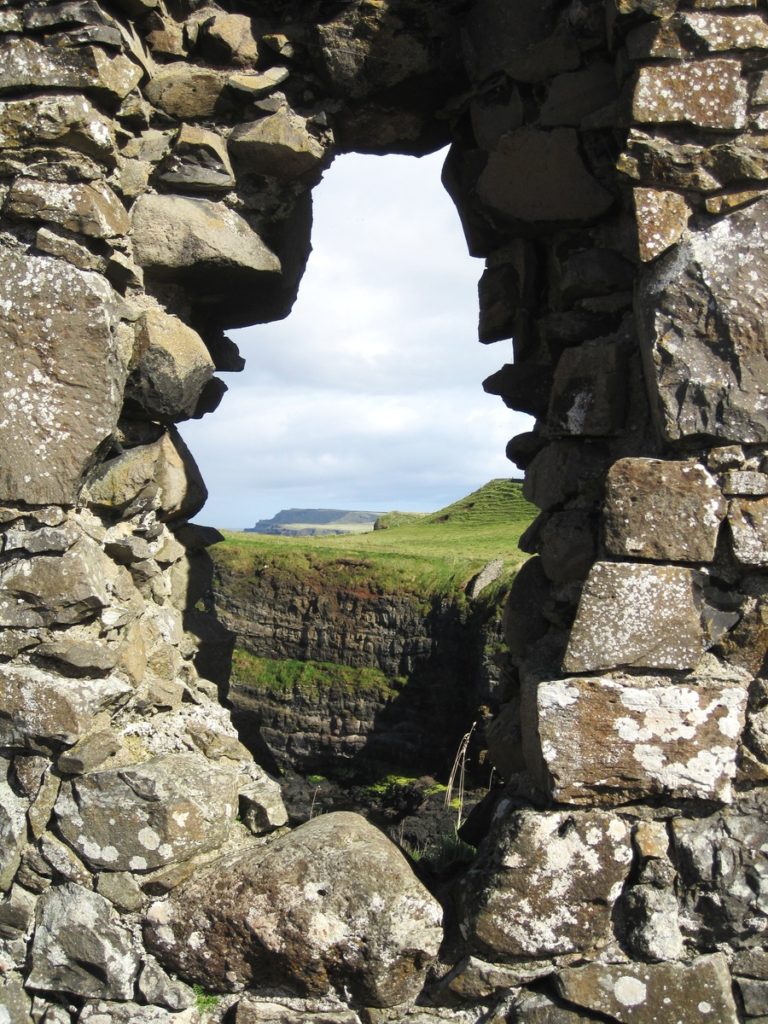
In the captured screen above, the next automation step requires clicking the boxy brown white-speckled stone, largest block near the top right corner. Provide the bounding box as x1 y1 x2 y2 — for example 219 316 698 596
632 58 748 130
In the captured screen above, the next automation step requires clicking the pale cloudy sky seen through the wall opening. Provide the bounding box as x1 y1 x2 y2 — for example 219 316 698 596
180 153 530 529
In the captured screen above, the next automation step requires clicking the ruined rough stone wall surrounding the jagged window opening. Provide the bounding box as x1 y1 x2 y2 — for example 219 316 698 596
0 0 768 1024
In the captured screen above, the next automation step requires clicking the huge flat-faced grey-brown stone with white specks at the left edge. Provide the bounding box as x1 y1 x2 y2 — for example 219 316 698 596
0 252 126 504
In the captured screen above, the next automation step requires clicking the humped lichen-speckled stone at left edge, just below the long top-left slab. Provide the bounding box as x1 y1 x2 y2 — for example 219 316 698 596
0 92 115 165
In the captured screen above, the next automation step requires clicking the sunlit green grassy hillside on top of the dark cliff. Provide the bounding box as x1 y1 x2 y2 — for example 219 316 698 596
211 479 537 595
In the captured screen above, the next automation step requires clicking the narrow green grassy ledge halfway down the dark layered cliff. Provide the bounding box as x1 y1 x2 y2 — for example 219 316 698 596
231 647 402 699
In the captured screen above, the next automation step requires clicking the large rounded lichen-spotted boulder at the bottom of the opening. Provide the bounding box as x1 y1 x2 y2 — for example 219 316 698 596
145 812 441 1006
